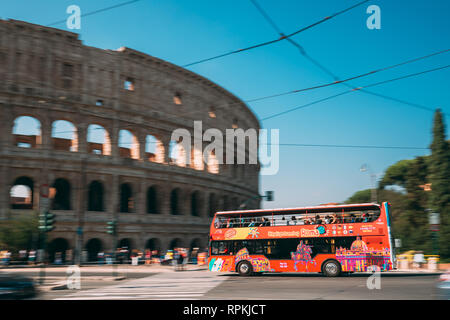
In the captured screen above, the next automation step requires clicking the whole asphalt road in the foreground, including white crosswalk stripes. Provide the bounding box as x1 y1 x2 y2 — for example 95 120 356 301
4 267 442 300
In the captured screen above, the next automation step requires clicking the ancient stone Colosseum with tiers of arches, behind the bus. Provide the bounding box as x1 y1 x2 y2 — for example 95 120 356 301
0 20 260 260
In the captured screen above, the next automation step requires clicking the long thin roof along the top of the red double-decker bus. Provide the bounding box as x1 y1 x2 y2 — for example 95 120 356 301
216 203 380 216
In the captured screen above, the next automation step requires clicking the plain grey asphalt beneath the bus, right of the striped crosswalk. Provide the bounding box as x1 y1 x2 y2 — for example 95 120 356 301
205 273 448 300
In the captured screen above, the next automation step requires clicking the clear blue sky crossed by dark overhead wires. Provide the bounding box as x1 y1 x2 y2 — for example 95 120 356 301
0 0 450 208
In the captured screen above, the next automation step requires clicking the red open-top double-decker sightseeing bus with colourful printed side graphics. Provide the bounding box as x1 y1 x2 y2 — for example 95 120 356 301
208 202 395 277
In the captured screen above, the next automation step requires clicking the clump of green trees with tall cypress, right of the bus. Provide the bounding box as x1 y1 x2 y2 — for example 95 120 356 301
346 110 450 259
